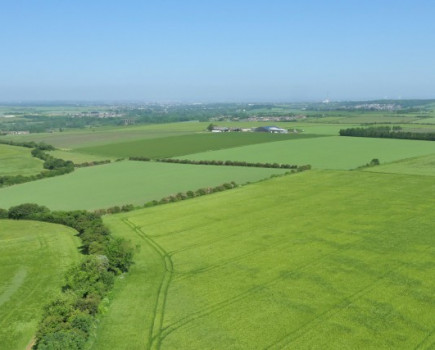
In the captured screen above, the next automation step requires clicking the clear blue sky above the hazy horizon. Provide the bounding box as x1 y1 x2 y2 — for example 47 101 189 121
0 0 435 102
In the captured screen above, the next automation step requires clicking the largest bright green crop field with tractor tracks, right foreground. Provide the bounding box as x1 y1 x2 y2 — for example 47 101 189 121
93 171 435 349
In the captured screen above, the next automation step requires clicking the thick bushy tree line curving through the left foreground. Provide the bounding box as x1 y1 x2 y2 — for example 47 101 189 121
0 203 134 350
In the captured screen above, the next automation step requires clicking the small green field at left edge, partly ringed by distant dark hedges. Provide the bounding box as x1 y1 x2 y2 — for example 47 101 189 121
0 144 43 176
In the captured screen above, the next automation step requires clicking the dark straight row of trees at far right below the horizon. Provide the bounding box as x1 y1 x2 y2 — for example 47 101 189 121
340 126 435 141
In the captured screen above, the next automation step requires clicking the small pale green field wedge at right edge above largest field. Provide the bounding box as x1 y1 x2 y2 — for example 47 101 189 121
365 153 435 176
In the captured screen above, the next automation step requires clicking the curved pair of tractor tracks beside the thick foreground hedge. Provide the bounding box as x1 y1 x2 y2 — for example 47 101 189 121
122 218 174 350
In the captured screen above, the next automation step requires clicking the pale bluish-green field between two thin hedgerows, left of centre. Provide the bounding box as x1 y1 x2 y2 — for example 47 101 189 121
0 161 286 210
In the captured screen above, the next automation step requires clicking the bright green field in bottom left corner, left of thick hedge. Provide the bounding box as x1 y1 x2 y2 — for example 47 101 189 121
0 220 80 350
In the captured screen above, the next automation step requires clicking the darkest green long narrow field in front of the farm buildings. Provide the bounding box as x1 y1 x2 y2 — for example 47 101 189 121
78 132 316 158
